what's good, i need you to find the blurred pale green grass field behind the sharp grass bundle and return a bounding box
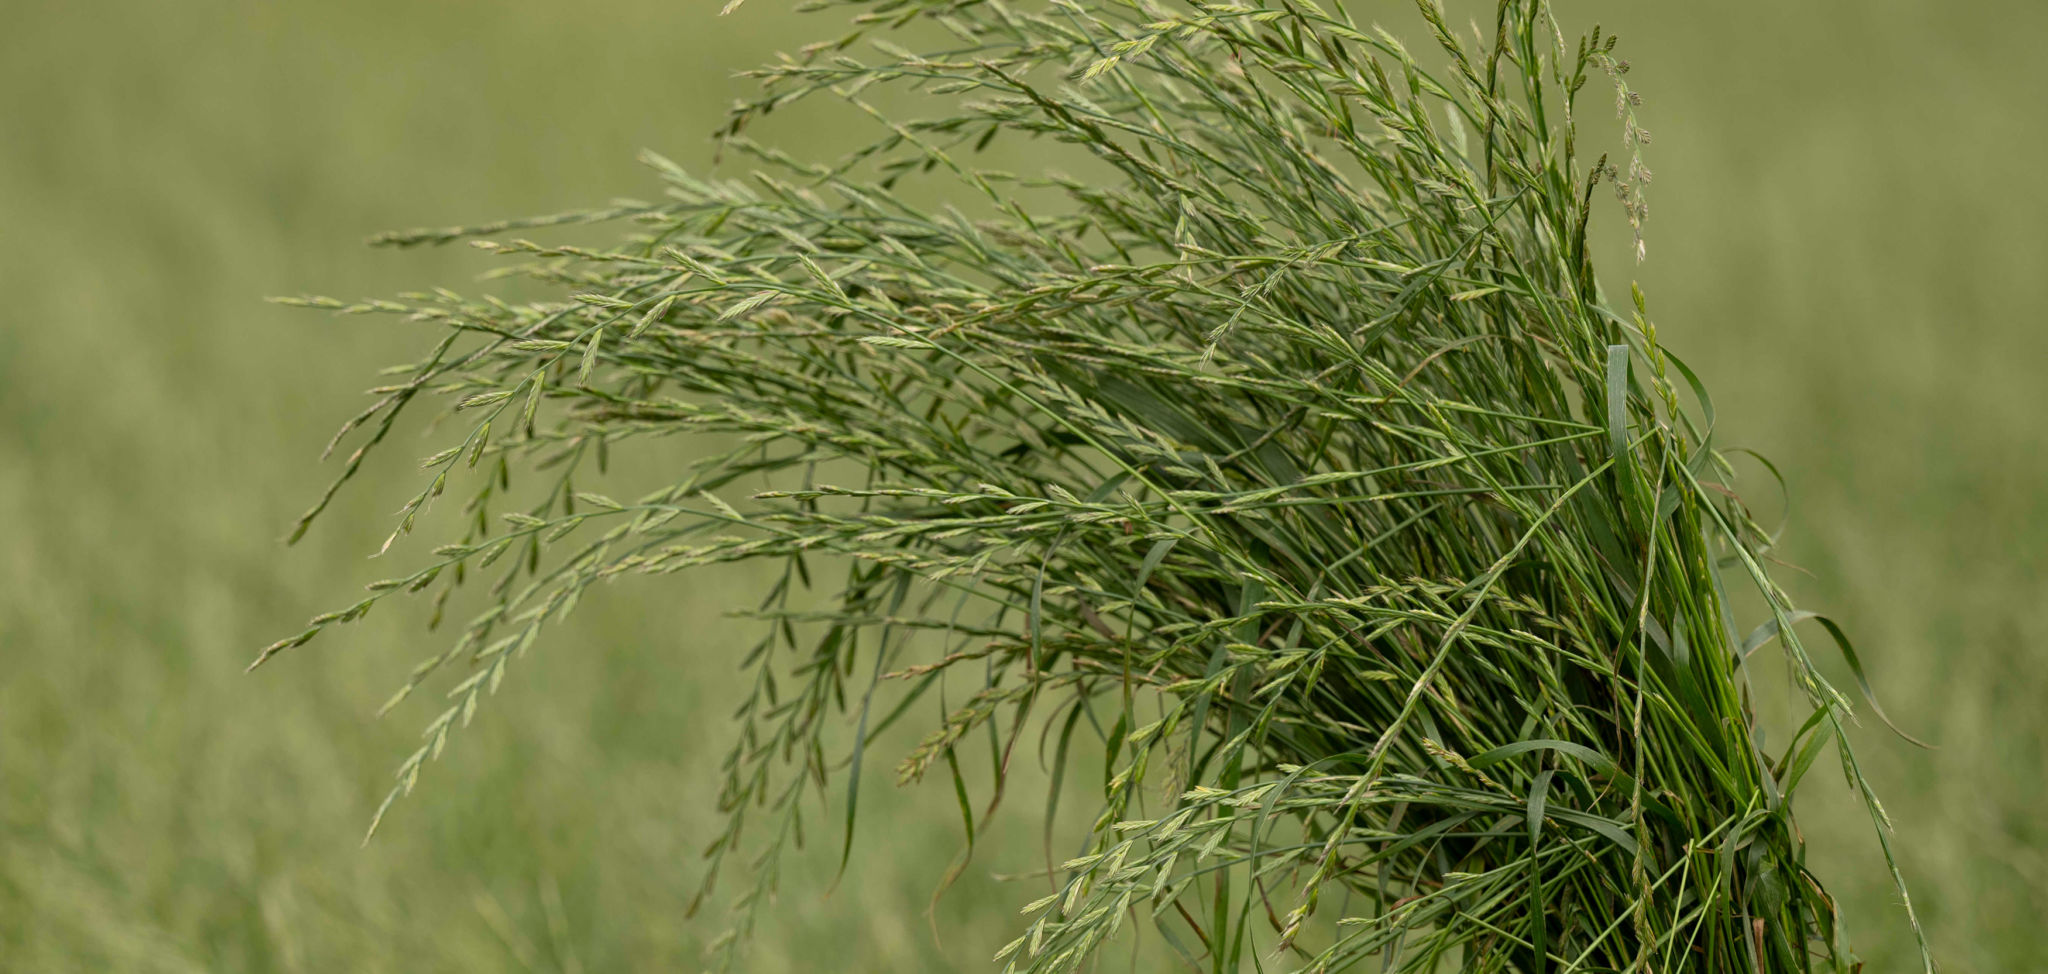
[0,0,2048,972]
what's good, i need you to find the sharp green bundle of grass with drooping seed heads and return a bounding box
[262,0,1931,972]
